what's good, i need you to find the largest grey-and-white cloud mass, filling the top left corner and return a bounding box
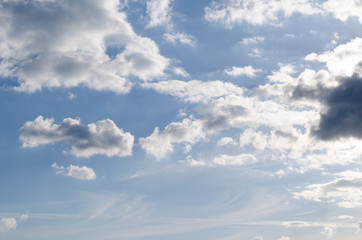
[0,0,169,93]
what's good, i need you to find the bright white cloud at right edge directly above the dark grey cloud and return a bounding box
[305,38,362,77]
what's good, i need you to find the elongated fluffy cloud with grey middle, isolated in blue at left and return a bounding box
[20,116,134,157]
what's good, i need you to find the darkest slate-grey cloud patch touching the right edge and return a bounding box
[313,76,362,140]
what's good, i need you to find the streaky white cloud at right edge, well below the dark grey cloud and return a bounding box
[294,171,362,208]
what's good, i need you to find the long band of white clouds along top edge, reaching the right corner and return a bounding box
[205,0,362,28]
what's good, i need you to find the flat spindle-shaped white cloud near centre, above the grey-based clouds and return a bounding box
[141,80,243,103]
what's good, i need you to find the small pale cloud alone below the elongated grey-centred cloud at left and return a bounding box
[52,163,97,180]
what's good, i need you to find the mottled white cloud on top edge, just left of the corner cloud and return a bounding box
[205,0,320,28]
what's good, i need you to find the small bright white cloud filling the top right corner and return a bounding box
[323,0,362,23]
